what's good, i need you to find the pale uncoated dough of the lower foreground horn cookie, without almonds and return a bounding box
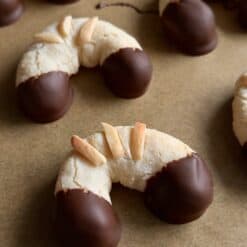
[55,126,194,202]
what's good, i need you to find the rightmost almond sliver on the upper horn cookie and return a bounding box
[78,17,99,46]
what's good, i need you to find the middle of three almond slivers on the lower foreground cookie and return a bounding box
[101,123,124,159]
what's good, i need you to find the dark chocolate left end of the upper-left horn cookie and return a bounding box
[17,71,73,123]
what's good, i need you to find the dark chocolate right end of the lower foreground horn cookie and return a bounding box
[145,154,213,224]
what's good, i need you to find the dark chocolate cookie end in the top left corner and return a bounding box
[0,0,24,27]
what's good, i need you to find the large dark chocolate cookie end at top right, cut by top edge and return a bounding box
[161,0,218,55]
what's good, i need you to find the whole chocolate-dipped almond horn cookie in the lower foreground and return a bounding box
[55,123,213,247]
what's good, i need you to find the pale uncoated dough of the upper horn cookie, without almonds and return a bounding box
[16,18,142,86]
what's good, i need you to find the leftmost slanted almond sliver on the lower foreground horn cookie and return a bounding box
[71,135,106,166]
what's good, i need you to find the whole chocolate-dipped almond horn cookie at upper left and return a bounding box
[16,16,152,122]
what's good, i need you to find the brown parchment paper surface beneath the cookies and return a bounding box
[0,0,247,247]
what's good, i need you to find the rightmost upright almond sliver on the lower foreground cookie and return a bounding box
[131,122,146,160]
